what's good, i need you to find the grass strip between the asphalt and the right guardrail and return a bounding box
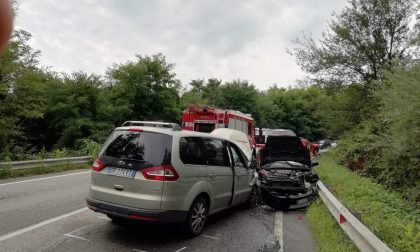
[307,199,359,252]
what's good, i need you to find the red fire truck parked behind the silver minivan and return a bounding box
[182,104,255,148]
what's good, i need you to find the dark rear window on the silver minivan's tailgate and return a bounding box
[99,130,172,168]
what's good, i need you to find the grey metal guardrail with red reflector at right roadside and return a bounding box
[318,181,392,252]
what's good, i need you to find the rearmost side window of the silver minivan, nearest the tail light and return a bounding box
[179,137,206,165]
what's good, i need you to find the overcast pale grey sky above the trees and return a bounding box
[16,0,346,89]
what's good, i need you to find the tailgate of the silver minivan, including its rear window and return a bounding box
[91,130,172,209]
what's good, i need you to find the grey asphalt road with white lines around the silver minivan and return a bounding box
[0,170,318,252]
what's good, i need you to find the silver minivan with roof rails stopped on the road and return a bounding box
[87,126,258,236]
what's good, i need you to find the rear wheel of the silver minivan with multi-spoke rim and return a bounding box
[184,197,209,237]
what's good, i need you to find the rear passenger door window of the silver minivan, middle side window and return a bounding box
[204,138,230,167]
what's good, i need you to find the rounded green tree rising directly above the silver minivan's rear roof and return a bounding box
[107,54,181,123]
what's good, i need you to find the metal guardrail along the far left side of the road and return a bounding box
[0,156,92,170]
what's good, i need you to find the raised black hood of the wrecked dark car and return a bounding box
[261,136,311,167]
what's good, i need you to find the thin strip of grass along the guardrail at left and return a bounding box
[0,163,90,179]
